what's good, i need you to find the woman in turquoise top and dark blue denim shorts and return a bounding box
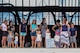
[30,20,37,48]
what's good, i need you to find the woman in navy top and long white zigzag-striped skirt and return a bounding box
[61,18,69,47]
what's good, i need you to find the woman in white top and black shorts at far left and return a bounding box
[1,20,8,48]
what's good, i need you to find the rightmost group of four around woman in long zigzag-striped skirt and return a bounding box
[52,18,77,48]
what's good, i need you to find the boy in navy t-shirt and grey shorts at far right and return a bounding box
[70,23,77,48]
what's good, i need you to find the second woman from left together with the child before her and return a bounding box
[8,21,15,47]
